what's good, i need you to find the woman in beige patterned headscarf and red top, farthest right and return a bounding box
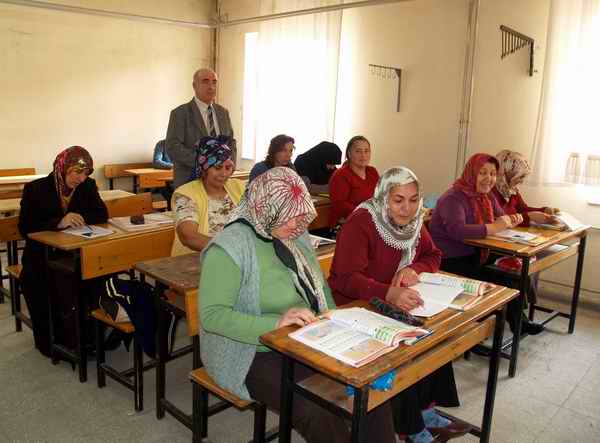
[492,149,560,226]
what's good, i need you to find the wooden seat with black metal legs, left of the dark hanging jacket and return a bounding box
[91,309,147,411]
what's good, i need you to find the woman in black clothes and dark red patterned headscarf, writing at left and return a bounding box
[19,146,108,357]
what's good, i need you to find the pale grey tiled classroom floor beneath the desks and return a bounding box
[0,286,600,443]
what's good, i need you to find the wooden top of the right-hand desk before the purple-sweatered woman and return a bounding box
[465,227,589,257]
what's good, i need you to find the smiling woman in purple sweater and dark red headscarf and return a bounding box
[430,154,544,335]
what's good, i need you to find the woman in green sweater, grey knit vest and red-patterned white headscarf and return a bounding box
[198,167,395,443]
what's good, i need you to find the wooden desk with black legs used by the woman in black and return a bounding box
[29,224,175,382]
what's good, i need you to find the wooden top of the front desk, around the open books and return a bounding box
[260,286,518,388]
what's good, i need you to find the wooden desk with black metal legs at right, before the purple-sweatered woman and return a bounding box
[465,227,589,377]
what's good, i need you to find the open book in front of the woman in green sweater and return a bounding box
[290,308,431,368]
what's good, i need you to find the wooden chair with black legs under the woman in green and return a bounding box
[185,291,278,443]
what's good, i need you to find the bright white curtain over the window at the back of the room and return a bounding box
[244,0,341,161]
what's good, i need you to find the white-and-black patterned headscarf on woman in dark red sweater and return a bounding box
[357,167,425,270]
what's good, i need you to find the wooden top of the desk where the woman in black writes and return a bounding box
[29,223,173,251]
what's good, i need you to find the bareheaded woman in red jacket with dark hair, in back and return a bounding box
[329,135,379,228]
